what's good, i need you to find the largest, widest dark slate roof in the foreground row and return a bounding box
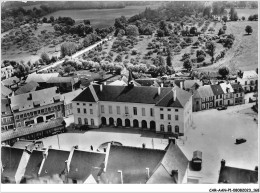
[101,145,165,184]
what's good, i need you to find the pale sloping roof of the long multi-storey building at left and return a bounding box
[11,87,60,111]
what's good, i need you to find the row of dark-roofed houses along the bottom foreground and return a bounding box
[1,138,205,184]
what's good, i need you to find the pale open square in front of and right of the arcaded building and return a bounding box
[42,103,258,183]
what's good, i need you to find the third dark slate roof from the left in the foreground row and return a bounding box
[40,149,70,177]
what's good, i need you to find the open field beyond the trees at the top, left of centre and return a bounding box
[46,5,160,28]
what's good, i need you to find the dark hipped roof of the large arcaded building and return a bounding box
[73,85,191,107]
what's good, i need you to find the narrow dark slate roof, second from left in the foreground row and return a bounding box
[24,150,43,178]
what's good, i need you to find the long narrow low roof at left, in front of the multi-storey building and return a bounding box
[1,118,63,142]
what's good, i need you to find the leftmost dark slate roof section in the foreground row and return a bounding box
[1,146,24,182]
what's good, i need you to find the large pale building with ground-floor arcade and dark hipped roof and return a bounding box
[72,85,192,135]
